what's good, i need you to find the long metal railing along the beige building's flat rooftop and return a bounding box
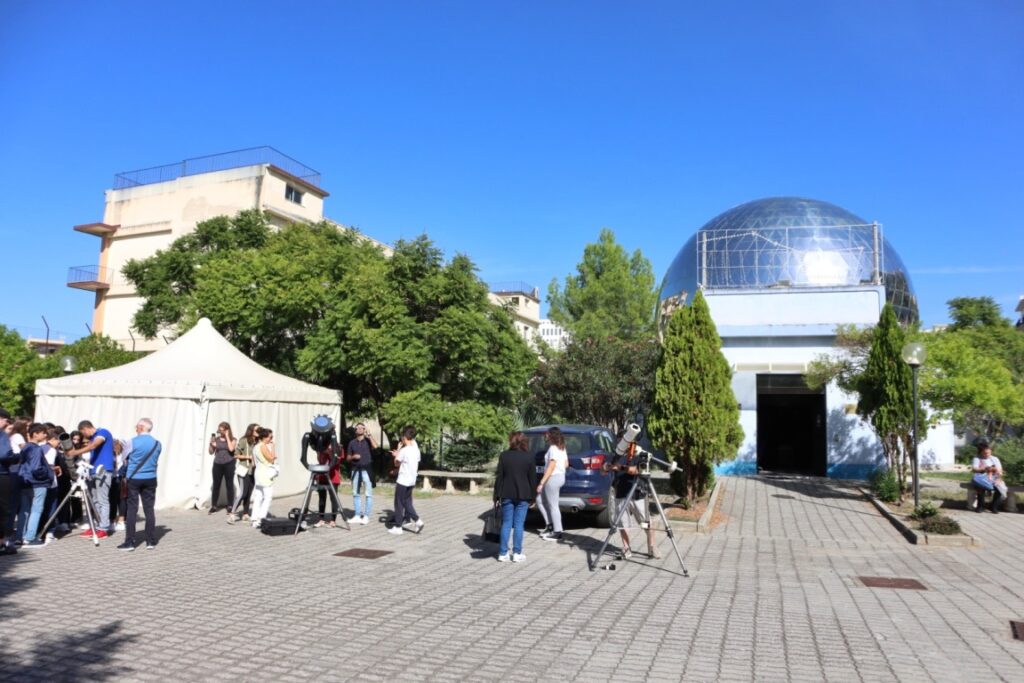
[114,146,321,189]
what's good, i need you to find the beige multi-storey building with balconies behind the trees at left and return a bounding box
[68,147,390,351]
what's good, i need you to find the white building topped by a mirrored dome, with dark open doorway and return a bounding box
[658,197,953,478]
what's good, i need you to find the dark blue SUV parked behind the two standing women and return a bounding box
[522,425,615,528]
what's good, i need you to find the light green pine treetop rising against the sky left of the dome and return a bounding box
[548,228,657,340]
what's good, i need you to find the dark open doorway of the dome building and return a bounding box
[758,375,827,476]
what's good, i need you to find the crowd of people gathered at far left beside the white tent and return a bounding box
[0,409,162,555]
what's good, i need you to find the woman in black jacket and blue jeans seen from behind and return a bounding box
[495,432,537,562]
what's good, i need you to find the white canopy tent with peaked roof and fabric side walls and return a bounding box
[36,317,341,508]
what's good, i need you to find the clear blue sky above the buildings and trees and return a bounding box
[0,0,1024,339]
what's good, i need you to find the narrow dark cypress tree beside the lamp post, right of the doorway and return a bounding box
[857,303,925,495]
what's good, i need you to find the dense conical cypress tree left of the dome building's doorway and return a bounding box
[647,292,743,504]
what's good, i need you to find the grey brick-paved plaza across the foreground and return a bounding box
[0,477,1024,681]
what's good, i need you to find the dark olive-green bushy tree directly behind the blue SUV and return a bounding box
[528,337,660,432]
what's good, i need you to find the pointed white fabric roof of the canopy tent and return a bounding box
[36,317,341,403]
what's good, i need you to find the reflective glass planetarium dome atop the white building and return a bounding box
[658,197,918,323]
